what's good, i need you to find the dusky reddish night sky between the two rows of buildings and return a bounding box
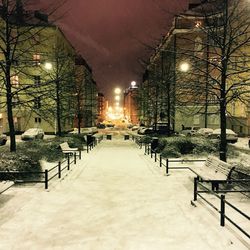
[33,0,188,100]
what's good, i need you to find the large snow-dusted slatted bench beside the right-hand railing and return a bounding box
[190,156,235,191]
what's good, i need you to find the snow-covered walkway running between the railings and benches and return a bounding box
[0,135,250,250]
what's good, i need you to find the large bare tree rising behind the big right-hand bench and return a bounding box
[174,0,250,161]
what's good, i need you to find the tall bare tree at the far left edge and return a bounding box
[0,0,52,151]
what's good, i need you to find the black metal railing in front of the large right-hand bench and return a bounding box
[194,177,250,239]
